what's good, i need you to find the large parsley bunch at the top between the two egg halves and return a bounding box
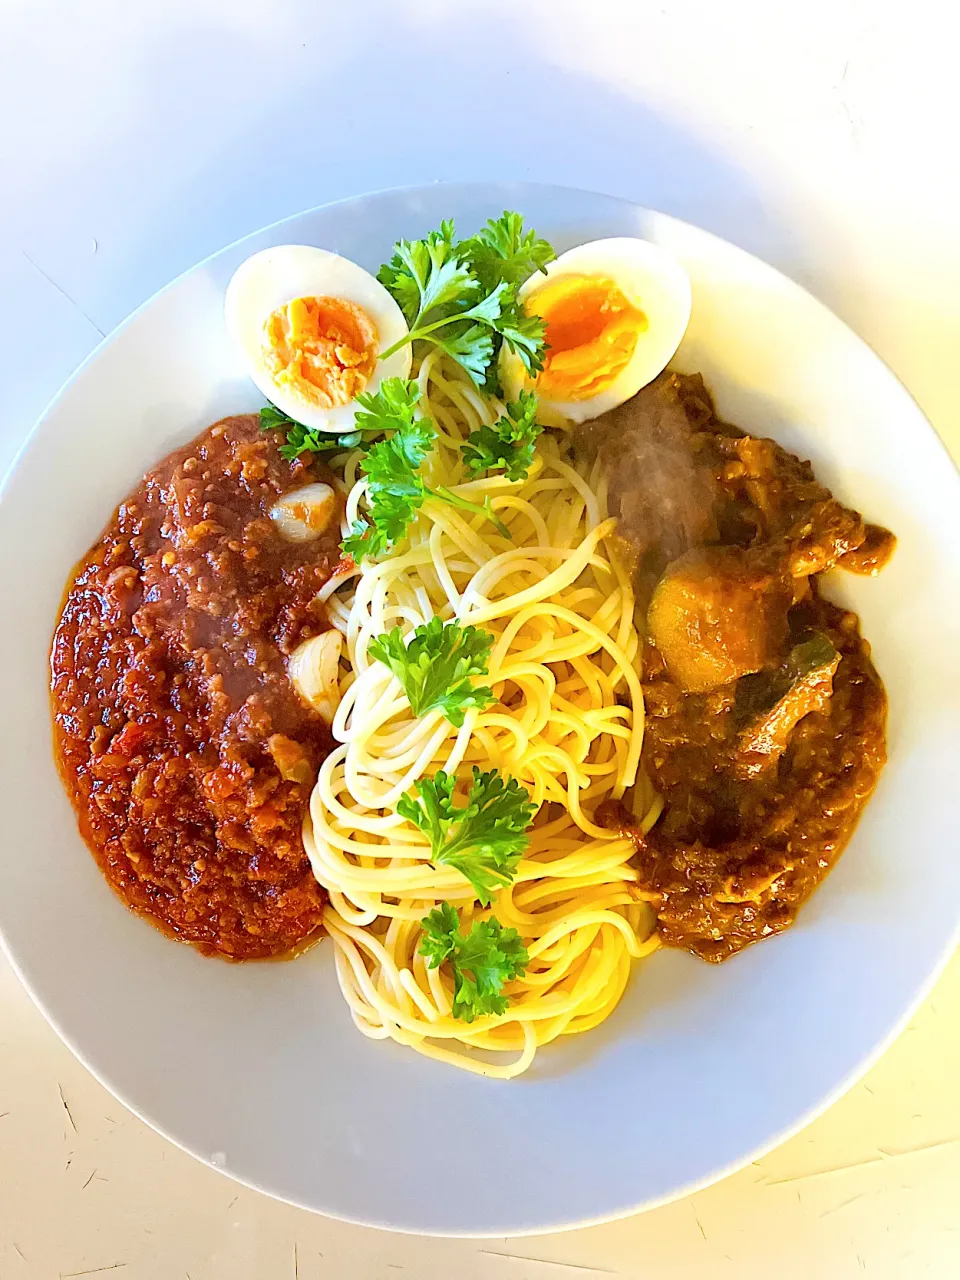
[378,212,556,387]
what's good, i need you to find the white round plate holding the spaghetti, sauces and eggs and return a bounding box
[0,184,960,1235]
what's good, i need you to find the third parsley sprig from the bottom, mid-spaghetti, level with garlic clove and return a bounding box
[367,618,497,728]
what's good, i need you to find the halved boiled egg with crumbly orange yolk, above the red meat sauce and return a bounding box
[224,244,411,431]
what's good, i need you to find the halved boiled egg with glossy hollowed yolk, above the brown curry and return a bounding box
[499,237,690,426]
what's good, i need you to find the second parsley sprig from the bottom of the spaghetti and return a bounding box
[397,765,536,906]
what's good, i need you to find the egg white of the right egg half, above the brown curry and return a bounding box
[499,236,691,425]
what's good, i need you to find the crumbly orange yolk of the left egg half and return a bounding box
[264,297,379,408]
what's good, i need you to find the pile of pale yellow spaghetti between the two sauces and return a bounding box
[303,352,658,1079]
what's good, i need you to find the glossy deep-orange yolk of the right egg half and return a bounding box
[524,275,648,401]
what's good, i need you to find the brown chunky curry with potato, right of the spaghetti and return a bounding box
[577,374,895,961]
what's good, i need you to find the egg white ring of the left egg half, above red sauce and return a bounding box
[224,244,412,431]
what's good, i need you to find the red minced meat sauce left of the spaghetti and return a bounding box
[51,415,339,960]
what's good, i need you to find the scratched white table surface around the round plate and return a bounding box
[0,0,960,1280]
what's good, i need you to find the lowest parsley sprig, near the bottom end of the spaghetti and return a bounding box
[420,902,530,1023]
